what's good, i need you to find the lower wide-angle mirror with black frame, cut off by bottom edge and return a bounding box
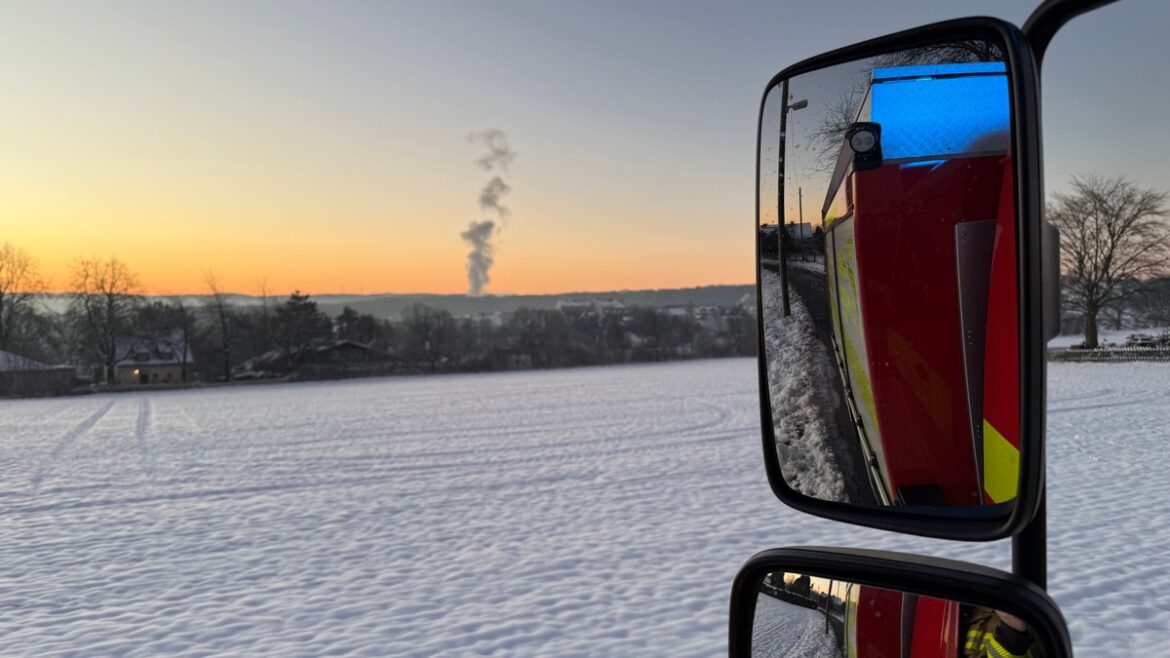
[729,548,1072,658]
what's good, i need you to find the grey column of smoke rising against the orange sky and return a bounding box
[459,129,516,296]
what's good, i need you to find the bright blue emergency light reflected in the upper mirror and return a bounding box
[858,62,1011,162]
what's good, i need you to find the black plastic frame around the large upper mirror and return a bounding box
[752,18,1046,541]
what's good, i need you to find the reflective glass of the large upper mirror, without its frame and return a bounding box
[757,41,1020,512]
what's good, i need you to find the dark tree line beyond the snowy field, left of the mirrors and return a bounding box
[0,248,756,382]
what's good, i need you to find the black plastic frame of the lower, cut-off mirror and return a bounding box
[728,547,1073,658]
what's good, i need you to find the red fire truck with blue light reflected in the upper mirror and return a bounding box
[823,63,1019,506]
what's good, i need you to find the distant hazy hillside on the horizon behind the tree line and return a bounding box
[36,285,756,317]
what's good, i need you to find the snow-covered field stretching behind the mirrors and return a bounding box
[0,359,1170,657]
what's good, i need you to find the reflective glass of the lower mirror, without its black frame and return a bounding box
[751,571,1042,658]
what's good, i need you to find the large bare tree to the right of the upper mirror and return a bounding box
[1047,176,1170,348]
